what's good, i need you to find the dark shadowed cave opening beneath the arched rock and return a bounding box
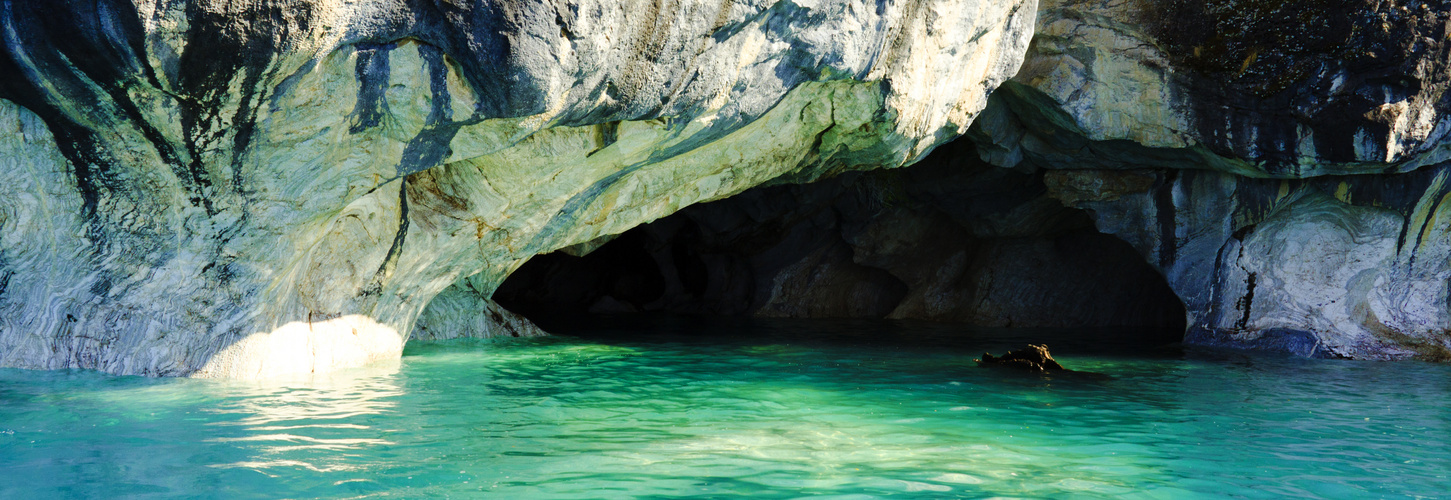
[493,139,1185,345]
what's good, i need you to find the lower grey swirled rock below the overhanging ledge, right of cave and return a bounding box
[1048,167,1451,361]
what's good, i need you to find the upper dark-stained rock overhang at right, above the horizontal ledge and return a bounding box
[982,0,1451,178]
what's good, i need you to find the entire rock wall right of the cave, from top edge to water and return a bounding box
[969,0,1451,359]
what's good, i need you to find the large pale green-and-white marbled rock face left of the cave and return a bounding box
[0,0,1036,377]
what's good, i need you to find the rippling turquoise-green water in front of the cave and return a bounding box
[0,320,1451,499]
